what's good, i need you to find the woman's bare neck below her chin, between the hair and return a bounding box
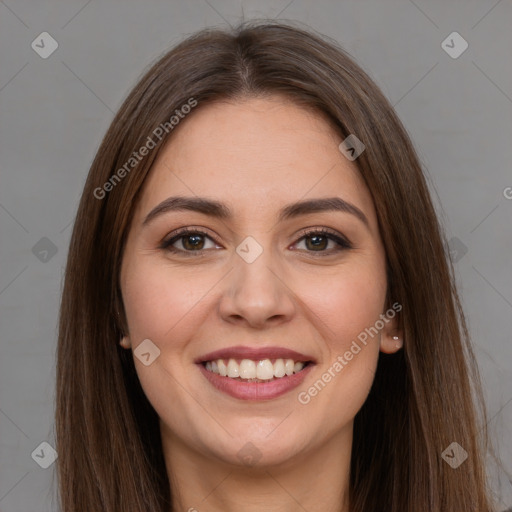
[162,425,352,512]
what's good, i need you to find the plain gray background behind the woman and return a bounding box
[0,0,512,512]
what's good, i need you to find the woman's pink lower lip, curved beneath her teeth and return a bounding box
[197,363,314,400]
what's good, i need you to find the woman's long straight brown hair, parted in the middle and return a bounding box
[56,22,492,512]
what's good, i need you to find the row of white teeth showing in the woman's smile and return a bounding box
[205,359,305,380]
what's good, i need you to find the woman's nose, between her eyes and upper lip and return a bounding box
[219,246,296,329]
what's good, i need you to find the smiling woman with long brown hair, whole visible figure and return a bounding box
[56,24,492,512]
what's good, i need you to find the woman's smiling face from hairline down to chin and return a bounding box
[121,96,396,465]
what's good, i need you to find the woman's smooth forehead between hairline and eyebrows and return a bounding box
[134,96,375,228]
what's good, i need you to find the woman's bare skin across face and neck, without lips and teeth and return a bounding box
[121,96,401,512]
